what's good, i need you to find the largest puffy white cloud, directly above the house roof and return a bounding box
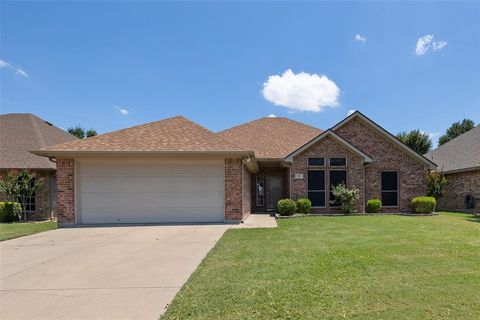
[262,69,340,112]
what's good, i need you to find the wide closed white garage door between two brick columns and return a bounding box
[76,160,224,224]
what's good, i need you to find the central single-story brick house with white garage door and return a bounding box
[30,112,436,224]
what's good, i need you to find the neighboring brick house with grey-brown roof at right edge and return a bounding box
[425,127,480,212]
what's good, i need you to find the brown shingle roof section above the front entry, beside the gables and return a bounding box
[218,117,323,159]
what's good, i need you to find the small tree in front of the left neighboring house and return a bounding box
[0,170,42,221]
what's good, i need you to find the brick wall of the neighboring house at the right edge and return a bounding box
[437,170,480,212]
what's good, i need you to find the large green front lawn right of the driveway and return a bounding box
[162,213,480,319]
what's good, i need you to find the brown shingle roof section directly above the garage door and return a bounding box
[36,116,247,154]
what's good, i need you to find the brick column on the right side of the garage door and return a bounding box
[225,158,242,221]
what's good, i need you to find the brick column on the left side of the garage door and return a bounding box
[57,158,75,224]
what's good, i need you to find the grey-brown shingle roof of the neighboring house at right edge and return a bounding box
[425,126,480,172]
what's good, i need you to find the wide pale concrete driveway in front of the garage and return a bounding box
[0,225,231,320]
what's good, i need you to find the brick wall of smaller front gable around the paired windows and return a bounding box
[290,137,365,213]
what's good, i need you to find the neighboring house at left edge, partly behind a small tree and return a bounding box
[0,113,77,220]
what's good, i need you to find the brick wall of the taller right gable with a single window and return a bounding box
[336,118,428,212]
